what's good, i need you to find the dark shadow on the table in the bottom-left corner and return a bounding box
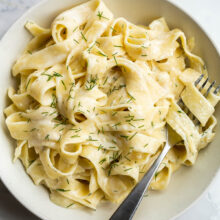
[0,180,39,220]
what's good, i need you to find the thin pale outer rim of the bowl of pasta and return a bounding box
[0,0,220,220]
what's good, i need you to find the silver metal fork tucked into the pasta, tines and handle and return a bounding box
[110,74,220,220]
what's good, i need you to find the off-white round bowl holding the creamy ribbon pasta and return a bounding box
[0,0,220,220]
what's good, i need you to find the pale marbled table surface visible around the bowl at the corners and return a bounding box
[0,0,220,220]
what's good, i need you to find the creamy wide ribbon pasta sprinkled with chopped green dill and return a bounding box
[4,0,220,209]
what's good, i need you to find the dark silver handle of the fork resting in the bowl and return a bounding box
[110,144,170,220]
